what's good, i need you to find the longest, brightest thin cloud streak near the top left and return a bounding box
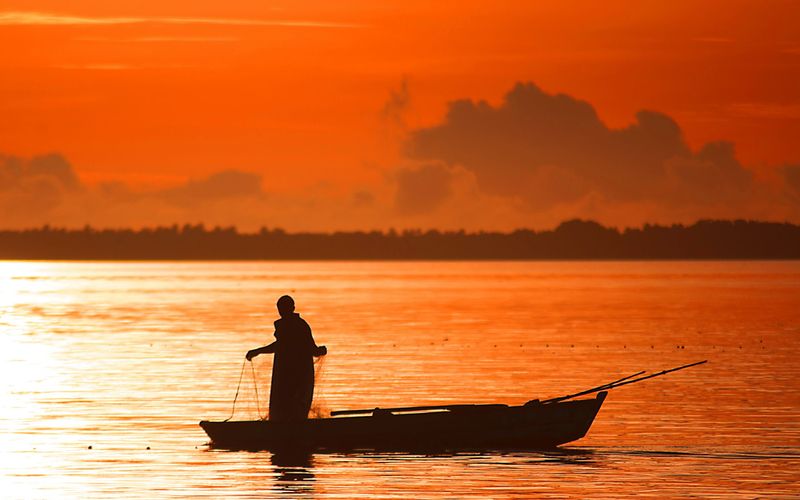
[0,12,361,28]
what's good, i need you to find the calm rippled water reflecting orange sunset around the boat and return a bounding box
[0,262,800,498]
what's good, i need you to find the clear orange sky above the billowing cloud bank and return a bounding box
[0,0,800,227]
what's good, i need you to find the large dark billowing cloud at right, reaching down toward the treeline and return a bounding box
[404,83,798,222]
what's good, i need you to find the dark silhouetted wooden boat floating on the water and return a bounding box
[200,391,607,451]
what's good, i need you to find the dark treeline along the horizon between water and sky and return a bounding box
[0,219,800,260]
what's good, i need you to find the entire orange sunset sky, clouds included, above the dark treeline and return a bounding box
[0,0,800,230]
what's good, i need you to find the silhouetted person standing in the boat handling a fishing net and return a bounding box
[246,295,328,421]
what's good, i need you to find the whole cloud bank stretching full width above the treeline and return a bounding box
[0,83,800,231]
